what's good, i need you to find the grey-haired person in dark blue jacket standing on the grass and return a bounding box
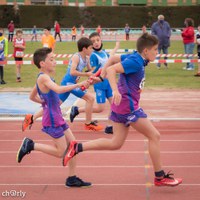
[151,15,171,69]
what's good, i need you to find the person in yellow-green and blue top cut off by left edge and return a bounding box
[0,28,8,84]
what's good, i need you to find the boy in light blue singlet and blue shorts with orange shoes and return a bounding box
[22,37,103,131]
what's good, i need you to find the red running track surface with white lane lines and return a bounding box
[0,92,200,200]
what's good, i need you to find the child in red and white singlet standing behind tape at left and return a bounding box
[13,29,26,82]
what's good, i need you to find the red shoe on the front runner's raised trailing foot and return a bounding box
[63,141,77,166]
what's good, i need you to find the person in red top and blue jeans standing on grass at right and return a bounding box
[181,18,195,70]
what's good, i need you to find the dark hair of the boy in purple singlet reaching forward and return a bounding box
[33,47,52,69]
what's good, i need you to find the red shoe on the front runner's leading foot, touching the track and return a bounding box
[154,172,182,187]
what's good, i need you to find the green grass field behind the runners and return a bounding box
[1,41,200,90]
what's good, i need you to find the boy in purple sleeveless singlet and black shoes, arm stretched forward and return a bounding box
[17,47,91,187]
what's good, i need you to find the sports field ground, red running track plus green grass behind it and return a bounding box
[0,38,200,200]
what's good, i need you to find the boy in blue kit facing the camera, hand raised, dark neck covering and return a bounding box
[70,32,119,134]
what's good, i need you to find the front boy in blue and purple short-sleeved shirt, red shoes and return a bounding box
[63,33,182,186]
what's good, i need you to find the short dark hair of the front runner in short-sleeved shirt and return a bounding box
[136,33,158,53]
